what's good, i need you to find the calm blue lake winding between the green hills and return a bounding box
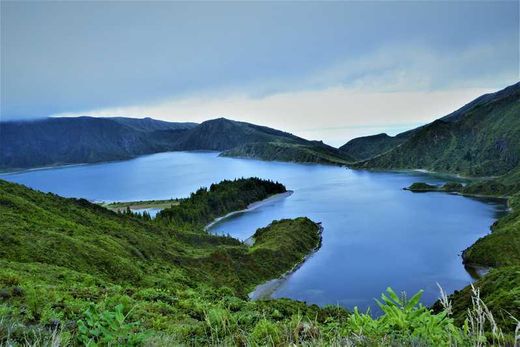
[0,152,504,309]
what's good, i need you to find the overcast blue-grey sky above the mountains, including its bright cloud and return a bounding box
[0,0,520,145]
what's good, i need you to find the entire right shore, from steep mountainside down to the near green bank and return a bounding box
[344,83,520,331]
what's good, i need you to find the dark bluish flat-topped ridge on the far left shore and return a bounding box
[0,117,194,169]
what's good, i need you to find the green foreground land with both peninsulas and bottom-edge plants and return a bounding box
[0,179,516,346]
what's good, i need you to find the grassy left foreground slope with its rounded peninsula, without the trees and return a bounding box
[0,181,334,345]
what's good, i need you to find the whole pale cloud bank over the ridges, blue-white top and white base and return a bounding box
[50,40,518,145]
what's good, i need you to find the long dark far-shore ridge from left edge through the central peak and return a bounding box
[0,117,352,170]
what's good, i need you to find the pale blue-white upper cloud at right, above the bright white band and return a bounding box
[301,39,520,92]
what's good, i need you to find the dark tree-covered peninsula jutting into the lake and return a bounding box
[156,178,287,227]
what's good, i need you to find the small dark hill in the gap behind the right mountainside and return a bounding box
[339,133,409,160]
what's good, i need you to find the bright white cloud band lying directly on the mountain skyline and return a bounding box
[60,87,491,145]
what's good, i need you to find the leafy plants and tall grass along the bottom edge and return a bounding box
[0,286,520,347]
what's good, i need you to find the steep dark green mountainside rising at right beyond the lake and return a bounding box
[348,83,520,176]
